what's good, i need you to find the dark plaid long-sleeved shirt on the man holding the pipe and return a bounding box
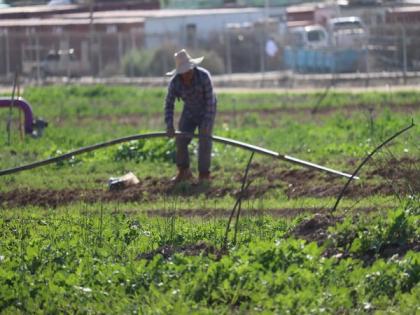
[165,67,217,128]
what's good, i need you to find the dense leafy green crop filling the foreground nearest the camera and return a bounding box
[0,201,420,314]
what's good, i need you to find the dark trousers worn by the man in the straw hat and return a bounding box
[176,114,213,173]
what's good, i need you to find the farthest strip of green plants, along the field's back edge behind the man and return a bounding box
[1,85,420,119]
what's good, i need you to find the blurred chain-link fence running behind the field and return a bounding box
[0,25,420,81]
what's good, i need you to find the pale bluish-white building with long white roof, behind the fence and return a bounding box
[53,8,286,48]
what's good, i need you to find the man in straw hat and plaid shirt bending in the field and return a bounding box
[165,49,217,183]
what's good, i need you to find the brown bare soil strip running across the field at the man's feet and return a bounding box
[0,158,420,208]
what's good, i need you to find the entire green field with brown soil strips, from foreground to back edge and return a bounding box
[0,86,420,314]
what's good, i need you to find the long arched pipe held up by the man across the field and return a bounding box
[0,131,358,179]
